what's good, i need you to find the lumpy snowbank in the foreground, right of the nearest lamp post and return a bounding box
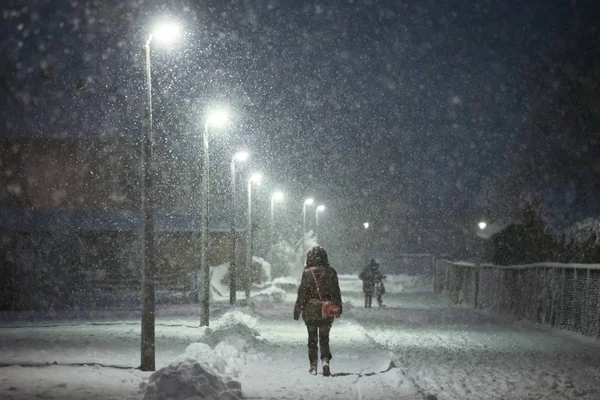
[144,310,265,400]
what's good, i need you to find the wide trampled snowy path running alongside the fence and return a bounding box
[354,293,600,400]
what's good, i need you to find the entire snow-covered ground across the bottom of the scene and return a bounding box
[0,275,600,400]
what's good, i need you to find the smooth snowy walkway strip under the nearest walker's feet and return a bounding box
[242,304,421,399]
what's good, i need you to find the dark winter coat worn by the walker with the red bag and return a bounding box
[294,266,342,322]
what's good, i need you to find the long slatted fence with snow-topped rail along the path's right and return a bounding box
[434,259,600,339]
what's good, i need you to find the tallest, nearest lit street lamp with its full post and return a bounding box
[140,24,179,371]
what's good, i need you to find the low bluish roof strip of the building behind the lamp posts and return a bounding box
[0,208,244,232]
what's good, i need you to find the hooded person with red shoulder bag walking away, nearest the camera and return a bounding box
[294,246,342,376]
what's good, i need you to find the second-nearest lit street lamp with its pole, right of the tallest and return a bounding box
[200,111,227,326]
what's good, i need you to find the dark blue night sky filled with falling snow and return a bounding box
[0,0,596,268]
